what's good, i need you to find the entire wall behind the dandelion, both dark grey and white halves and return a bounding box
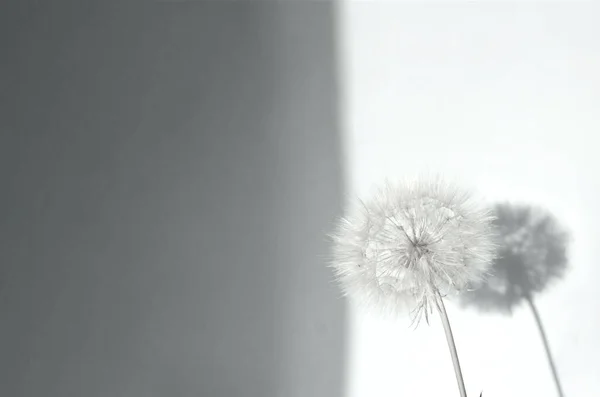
[0,1,600,397]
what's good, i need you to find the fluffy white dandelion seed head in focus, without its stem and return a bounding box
[331,178,496,319]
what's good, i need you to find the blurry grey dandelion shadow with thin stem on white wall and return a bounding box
[461,204,569,397]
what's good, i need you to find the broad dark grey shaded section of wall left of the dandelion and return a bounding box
[0,1,345,397]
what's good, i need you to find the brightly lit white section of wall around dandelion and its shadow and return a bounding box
[339,1,600,397]
